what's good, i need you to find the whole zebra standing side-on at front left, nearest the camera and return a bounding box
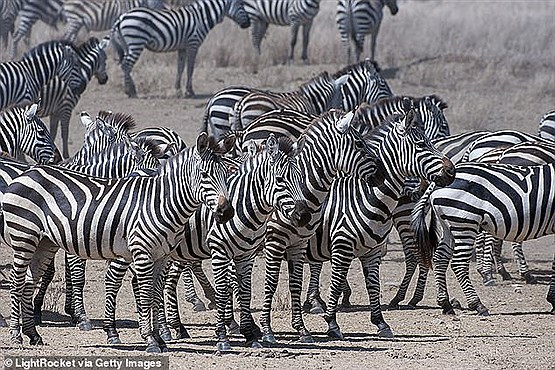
[2,133,234,352]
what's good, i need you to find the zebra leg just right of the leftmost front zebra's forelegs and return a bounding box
[164,261,191,339]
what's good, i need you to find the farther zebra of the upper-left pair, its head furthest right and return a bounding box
[39,37,110,158]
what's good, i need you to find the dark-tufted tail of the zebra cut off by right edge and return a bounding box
[411,182,437,269]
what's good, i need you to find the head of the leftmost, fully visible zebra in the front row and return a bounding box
[192,132,235,223]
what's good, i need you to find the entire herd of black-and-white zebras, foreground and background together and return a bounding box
[0,0,555,358]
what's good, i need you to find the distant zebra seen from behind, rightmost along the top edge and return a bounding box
[335,0,399,63]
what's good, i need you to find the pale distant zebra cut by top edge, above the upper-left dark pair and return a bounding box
[62,0,164,42]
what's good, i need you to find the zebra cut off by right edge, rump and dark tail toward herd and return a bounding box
[413,162,555,315]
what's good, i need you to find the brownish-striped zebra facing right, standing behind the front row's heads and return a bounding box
[229,72,348,130]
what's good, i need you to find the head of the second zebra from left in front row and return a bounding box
[266,134,312,227]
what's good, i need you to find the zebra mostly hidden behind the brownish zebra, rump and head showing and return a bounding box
[202,59,393,137]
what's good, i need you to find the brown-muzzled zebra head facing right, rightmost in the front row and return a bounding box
[365,109,455,194]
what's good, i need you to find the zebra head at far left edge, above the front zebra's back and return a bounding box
[18,104,62,164]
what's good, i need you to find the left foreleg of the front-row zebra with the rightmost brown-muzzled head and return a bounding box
[324,250,354,340]
